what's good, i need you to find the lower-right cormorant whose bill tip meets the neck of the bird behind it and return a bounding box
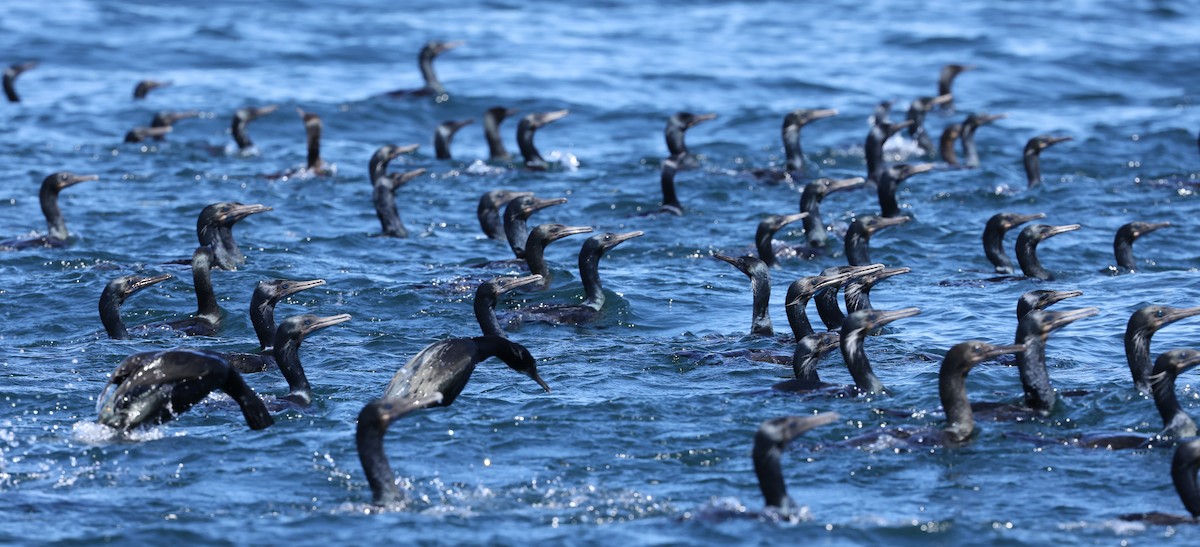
[937,339,1025,445]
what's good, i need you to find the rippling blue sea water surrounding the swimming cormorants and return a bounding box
[0,0,1200,545]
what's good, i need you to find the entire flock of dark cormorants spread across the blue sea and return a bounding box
[7,41,1200,523]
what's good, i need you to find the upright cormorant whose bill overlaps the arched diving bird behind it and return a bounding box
[354,393,451,505]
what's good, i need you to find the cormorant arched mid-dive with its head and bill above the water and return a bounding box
[383,336,550,407]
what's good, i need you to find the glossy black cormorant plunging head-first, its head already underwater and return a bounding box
[97,349,275,432]
